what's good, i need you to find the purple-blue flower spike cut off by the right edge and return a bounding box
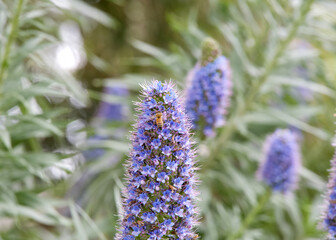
[323,153,336,236]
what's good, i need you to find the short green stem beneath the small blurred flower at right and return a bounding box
[227,189,272,240]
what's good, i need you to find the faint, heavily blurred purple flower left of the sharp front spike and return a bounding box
[97,86,129,121]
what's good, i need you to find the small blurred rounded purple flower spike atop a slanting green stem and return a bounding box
[258,129,301,193]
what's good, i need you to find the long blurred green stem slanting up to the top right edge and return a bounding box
[205,0,314,165]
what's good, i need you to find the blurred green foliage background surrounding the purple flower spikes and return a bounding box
[0,0,336,240]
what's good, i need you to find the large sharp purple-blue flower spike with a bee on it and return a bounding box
[116,81,197,240]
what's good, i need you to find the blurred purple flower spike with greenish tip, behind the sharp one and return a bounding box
[186,38,232,137]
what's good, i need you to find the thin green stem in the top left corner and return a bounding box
[0,0,24,86]
